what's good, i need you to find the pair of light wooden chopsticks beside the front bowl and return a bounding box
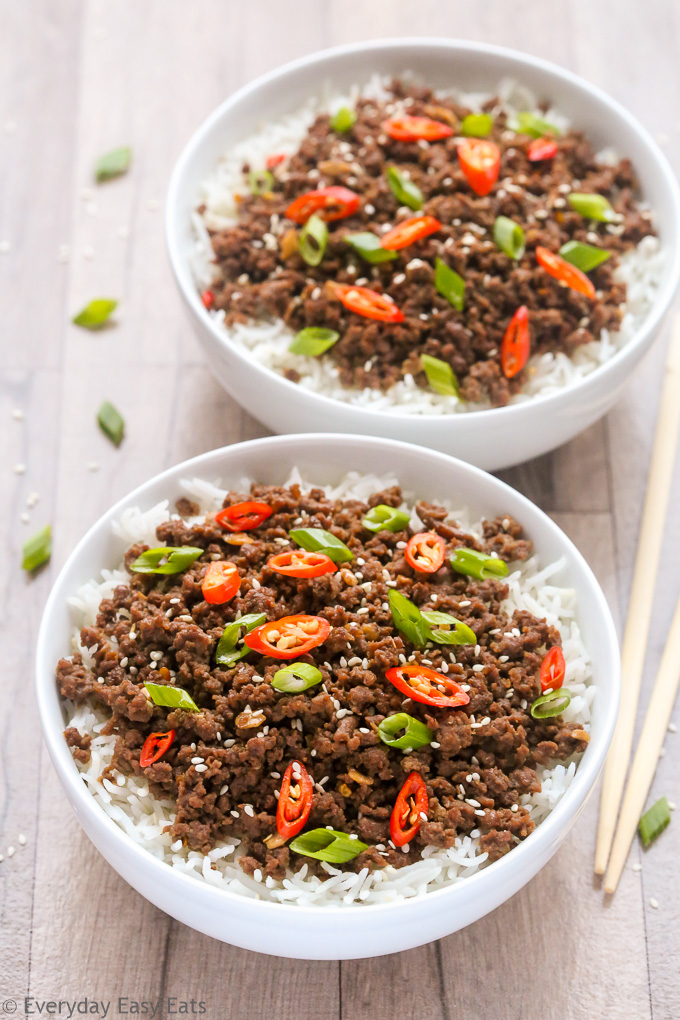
[594,315,680,893]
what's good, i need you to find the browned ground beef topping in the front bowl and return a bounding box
[57,485,588,878]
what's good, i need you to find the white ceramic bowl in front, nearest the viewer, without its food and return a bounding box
[37,434,620,960]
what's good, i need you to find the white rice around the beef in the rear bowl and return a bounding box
[190,77,664,414]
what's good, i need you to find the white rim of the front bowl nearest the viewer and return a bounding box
[36,432,619,921]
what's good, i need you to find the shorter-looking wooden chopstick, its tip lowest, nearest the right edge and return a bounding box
[605,599,680,893]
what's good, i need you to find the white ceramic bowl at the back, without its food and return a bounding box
[166,39,680,470]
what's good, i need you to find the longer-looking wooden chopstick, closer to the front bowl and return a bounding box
[594,315,680,875]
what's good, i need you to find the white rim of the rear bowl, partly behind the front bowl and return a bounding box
[165,37,680,429]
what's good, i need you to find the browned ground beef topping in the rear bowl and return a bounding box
[203,81,653,406]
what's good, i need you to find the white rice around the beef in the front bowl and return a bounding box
[64,472,595,906]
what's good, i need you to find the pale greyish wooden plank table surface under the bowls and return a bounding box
[0,0,680,1020]
